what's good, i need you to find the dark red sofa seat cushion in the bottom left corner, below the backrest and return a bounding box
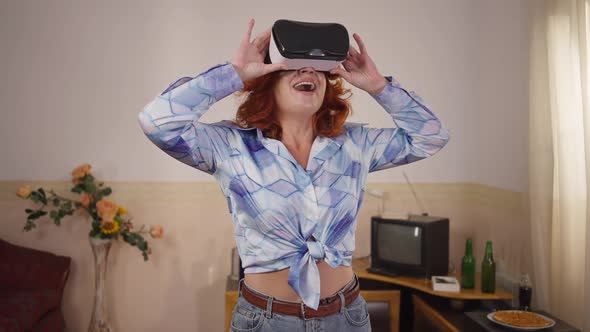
[0,290,61,330]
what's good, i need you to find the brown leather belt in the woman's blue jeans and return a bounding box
[241,277,360,319]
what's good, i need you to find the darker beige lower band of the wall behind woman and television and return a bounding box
[0,181,530,332]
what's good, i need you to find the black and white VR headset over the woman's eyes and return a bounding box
[264,20,349,71]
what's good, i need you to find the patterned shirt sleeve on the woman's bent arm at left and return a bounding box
[138,63,243,174]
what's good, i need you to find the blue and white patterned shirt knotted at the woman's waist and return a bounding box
[139,63,449,309]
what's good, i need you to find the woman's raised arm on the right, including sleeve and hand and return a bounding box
[331,33,449,172]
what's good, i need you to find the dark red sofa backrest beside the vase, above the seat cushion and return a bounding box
[0,239,70,289]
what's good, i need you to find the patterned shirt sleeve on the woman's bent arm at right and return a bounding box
[349,77,449,172]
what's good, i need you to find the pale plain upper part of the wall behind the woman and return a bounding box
[0,0,528,191]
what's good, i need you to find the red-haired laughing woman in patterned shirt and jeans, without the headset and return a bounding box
[139,20,448,332]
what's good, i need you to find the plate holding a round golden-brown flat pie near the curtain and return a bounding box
[487,310,555,331]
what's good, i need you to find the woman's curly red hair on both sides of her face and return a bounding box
[236,71,352,140]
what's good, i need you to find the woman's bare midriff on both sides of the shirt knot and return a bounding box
[244,261,354,302]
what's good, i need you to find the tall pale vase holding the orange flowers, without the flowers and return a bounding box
[88,237,113,332]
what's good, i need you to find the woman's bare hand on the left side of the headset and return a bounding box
[231,19,287,82]
